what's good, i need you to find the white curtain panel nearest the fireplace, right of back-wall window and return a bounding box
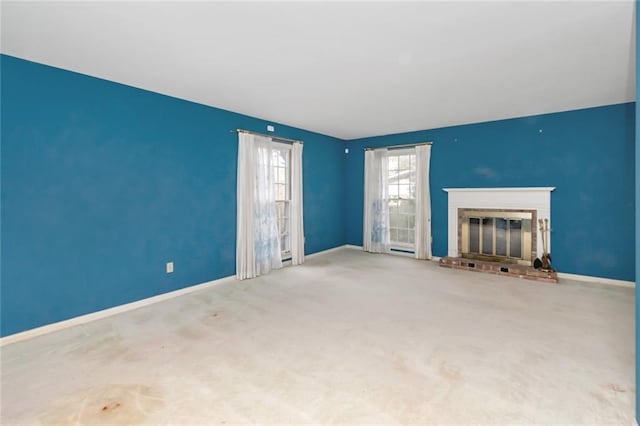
[415,145,431,259]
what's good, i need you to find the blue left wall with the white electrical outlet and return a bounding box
[0,56,345,335]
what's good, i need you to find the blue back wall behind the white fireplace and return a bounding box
[345,103,635,280]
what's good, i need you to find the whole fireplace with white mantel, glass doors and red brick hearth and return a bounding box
[440,187,557,282]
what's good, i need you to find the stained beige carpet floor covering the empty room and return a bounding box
[0,248,636,425]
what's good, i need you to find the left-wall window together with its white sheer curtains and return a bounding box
[236,129,304,280]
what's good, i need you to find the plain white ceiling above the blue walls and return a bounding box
[1,1,635,139]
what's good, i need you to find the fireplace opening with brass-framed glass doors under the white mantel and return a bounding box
[458,209,536,265]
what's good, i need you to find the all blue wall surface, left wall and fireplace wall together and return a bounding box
[0,56,640,335]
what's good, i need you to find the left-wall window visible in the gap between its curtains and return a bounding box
[271,142,291,260]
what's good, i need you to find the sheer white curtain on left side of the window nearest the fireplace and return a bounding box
[363,148,389,253]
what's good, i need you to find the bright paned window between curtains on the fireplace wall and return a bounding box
[387,149,416,251]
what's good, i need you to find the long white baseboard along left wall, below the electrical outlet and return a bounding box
[0,275,236,347]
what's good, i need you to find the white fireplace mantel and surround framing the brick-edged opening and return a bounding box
[443,187,556,257]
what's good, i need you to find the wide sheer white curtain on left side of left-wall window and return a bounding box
[236,132,282,280]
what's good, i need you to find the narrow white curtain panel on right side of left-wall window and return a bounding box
[289,142,304,265]
